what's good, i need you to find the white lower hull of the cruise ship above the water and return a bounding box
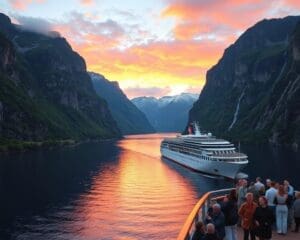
[161,148,247,179]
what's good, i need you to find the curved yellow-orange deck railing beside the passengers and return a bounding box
[177,188,234,240]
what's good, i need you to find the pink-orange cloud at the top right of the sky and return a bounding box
[161,0,270,39]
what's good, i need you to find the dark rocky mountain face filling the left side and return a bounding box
[0,14,121,141]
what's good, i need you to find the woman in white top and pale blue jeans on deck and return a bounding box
[275,185,288,235]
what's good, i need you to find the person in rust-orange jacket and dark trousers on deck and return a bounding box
[238,193,257,240]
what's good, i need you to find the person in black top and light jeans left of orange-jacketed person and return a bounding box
[222,189,239,240]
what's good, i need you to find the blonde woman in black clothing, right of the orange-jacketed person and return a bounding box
[253,197,275,240]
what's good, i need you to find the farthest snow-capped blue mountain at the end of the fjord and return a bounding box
[131,93,198,132]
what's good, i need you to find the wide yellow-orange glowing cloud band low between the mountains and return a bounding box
[73,38,224,91]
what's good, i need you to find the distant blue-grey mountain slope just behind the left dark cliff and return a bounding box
[89,72,155,134]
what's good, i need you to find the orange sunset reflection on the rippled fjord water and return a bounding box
[69,135,197,239]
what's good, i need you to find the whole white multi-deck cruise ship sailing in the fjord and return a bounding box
[160,123,248,179]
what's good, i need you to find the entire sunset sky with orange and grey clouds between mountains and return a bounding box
[0,0,300,98]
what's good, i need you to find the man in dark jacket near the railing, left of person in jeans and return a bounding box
[206,203,225,240]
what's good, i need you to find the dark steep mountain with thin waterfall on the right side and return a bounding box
[189,16,300,146]
